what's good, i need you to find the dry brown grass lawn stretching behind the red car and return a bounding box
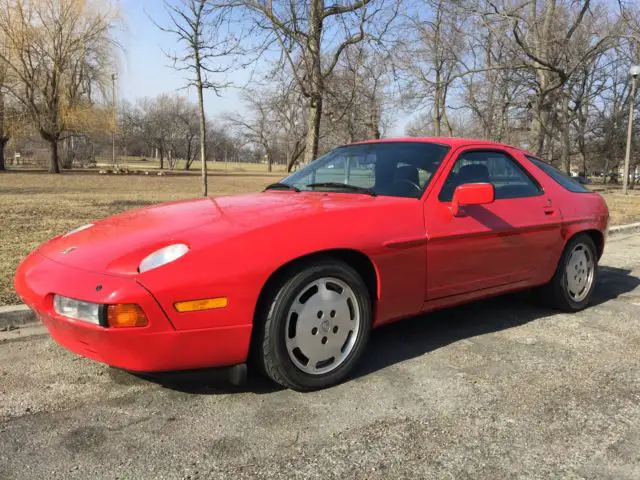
[0,167,640,305]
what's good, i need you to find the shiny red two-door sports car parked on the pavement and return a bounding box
[15,138,609,390]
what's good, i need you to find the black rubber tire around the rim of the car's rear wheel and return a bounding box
[541,233,598,312]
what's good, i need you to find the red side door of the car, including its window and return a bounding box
[425,147,561,302]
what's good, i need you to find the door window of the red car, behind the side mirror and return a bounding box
[438,150,542,202]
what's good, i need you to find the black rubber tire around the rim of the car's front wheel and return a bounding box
[254,259,372,392]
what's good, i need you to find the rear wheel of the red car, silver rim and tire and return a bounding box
[544,233,598,312]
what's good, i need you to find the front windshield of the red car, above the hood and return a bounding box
[280,142,449,198]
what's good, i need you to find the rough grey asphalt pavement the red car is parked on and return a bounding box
[0,235,640,480]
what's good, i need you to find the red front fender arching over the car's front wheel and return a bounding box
[138,199,426,330]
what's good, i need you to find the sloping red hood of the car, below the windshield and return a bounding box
[38,192,384,276]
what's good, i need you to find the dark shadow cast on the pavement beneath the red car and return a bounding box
[121,266,640,395]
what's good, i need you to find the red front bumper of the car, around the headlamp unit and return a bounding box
[14,251,251,372]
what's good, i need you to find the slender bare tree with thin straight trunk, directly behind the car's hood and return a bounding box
[156,0,239,196]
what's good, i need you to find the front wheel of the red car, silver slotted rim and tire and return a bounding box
[258,260,372,391]
